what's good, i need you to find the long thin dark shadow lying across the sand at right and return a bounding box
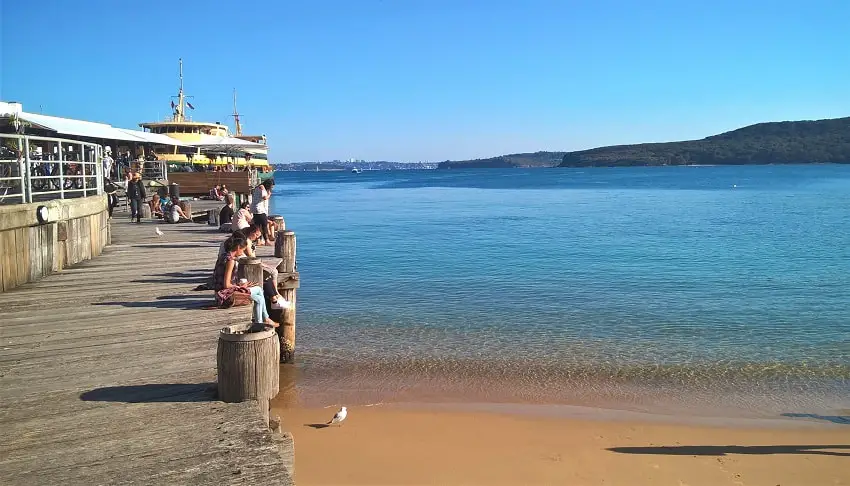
[606,444,850,457]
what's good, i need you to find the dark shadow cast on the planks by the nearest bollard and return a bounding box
[80,383,217,403]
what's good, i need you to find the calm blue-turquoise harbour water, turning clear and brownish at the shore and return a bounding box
[273,166,850,414]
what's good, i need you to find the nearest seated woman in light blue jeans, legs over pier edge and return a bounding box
[213,235,279,328]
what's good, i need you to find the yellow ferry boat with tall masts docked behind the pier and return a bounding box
[139,59,272,179]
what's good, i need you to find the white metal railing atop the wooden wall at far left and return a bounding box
[0,133,103,204]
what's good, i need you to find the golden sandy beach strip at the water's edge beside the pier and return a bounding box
[273,405,850,486]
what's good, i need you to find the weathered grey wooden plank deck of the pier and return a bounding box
[0,217,292,485]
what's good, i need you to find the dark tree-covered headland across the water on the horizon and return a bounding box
[438,117,850,169]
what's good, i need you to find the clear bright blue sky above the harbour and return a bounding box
[0,0,850,162]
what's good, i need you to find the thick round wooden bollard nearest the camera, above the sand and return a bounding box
[216,325,280,403]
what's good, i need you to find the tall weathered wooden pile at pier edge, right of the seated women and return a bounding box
[275,230,300,363]
